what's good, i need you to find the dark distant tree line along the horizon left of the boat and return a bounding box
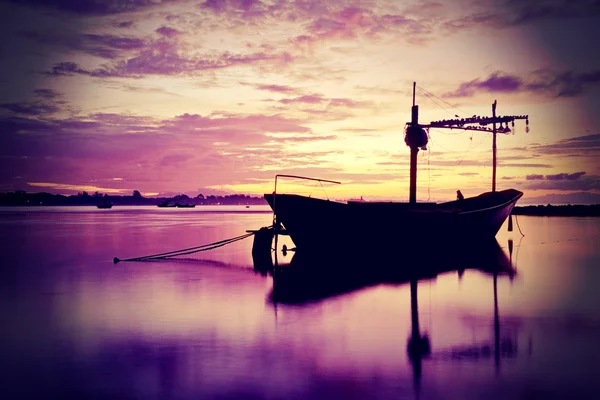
[0,190,267,206]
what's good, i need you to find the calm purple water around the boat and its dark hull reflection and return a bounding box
[0,207,600,399]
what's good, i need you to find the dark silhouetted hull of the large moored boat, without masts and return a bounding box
[265,189,523,250]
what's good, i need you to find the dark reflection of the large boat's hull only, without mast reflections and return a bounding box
[264,239,516,304]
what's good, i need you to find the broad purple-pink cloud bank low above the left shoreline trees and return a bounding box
[0,108,337,191]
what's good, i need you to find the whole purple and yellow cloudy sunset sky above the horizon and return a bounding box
[0,0,600,202]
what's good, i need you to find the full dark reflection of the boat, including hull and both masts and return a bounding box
[255,239,517,389]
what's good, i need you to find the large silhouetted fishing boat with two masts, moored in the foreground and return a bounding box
[264,84,529,254]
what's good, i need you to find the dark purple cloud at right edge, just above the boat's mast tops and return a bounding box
[443,70,600,97]
